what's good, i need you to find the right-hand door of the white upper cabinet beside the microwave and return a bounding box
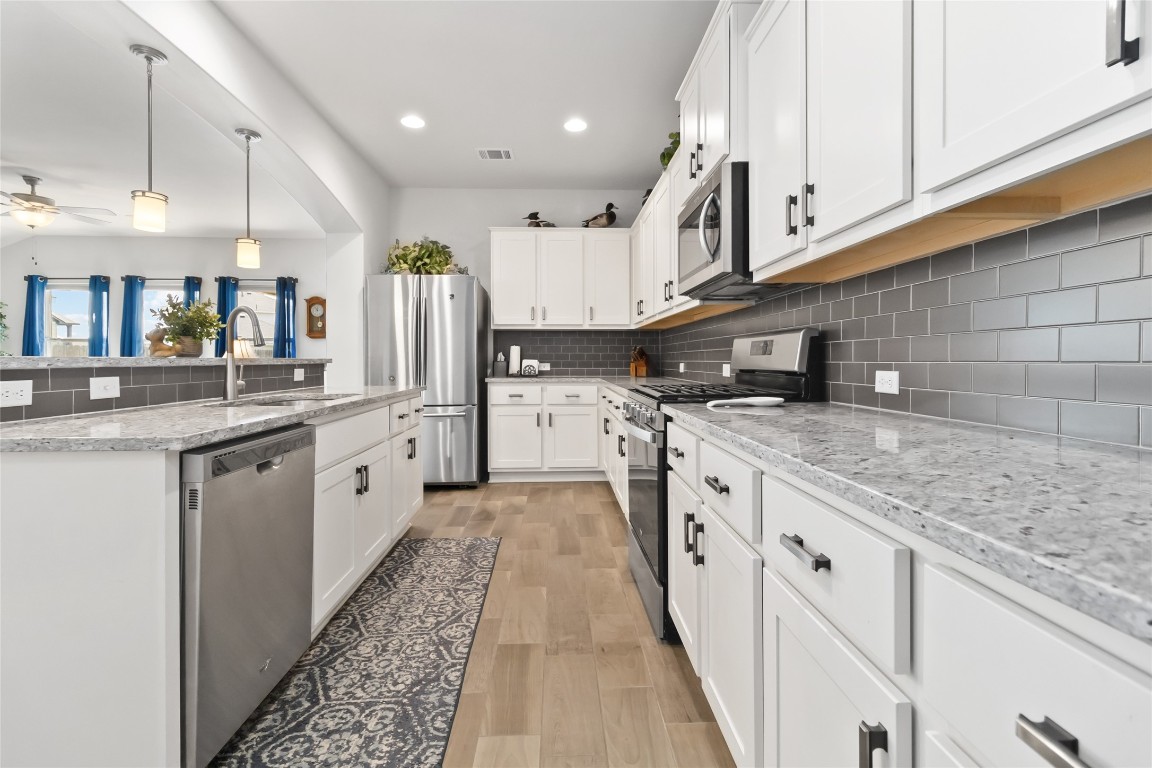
[806,0,912,241]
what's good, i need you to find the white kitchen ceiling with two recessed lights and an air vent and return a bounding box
[218,0,717,189]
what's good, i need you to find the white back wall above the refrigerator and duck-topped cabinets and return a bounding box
[389,188,659,289]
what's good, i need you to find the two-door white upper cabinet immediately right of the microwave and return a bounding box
[748,0,912,269]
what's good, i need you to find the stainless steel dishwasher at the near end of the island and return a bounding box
[181,426,316,768]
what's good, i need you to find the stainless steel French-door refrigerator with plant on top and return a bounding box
[365,275,488,485]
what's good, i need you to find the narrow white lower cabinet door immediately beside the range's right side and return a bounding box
[668,474,704,675]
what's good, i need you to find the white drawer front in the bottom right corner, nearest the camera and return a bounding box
[922,565,1152,767]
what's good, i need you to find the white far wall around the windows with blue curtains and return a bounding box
[0,236,328,357]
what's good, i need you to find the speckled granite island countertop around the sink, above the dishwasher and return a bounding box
[0,387,422,451]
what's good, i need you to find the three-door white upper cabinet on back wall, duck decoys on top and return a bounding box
[491,228,631,328]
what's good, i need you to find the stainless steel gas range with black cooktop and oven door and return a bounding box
[623,328,825,640]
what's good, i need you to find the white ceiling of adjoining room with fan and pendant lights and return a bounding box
[0,0,324,244]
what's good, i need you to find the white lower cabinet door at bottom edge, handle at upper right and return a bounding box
[763,569,912,768]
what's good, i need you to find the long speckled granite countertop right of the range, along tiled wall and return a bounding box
[665,403,1152,642]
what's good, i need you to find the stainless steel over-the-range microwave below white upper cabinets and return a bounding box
[676,162,803,303]
